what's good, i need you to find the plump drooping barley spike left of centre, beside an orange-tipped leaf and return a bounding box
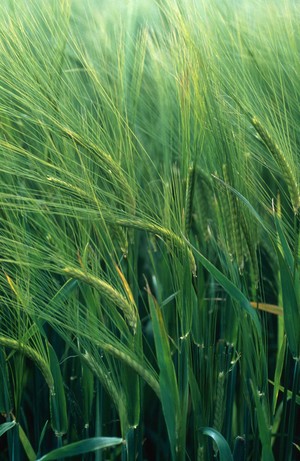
[62,266,137,332]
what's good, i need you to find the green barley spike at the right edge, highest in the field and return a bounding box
[251,116,300,214]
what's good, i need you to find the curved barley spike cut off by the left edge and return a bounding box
[0,335,54,392]
